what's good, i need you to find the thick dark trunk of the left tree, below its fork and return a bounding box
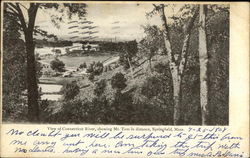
[25,29,39,122]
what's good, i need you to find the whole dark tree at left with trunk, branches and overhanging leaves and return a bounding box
[4,3,86,122]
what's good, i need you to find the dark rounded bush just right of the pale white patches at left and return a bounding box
[61,81,80,101]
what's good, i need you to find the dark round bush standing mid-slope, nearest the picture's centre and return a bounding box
[111,72,127,91]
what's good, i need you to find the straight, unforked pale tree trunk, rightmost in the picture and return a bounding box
[199,5,208,125]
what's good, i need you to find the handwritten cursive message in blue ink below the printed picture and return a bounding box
[5,127,245,157]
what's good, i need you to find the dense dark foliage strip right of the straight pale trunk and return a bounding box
[205,5,230,125]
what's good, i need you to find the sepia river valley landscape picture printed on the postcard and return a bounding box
[1,1,230,126]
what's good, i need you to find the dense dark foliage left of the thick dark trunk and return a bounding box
[2,7,26,120]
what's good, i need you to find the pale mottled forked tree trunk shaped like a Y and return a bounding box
[154,4,198,125]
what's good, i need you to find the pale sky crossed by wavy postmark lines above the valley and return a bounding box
[36,2,164,40]
